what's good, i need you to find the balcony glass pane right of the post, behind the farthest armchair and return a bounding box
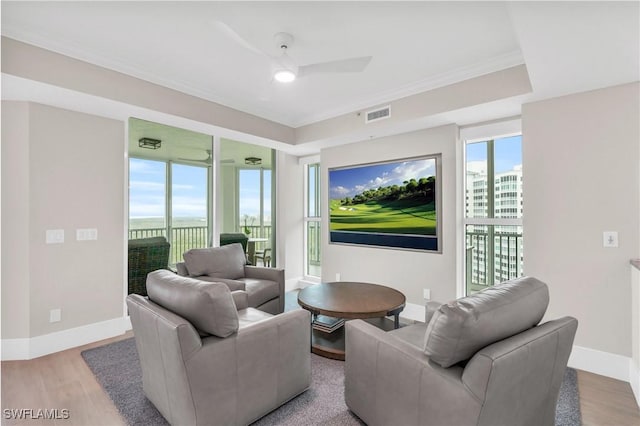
[169,164,208,265]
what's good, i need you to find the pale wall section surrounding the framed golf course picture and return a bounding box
[320,125,458,305]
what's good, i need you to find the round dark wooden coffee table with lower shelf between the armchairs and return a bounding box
[298,281,406,360]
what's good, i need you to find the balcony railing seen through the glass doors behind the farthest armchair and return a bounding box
[129,226,271,265]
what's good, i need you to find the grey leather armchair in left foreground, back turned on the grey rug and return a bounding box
[127,270,311,425]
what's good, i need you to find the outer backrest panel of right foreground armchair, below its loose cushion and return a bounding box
[462,317,578,426]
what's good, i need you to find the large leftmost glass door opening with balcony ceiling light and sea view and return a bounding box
[129,118,213,265]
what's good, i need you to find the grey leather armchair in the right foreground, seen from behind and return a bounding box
[345,277,578,426]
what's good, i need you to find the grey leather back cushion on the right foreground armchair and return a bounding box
[424,277,549,368]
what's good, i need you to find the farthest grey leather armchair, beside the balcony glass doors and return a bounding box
[176,243,284,315]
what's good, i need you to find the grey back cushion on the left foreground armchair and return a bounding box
[147,270,239,337]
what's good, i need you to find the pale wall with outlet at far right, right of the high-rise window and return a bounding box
[522,83,640,357]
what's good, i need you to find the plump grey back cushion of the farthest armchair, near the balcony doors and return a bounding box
[183,243,247,280]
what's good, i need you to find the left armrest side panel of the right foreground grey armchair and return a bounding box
[344,320,472,425]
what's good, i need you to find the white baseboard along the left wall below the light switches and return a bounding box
[1,317,131,361]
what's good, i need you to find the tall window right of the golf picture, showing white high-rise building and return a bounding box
[465,135,524,294]
